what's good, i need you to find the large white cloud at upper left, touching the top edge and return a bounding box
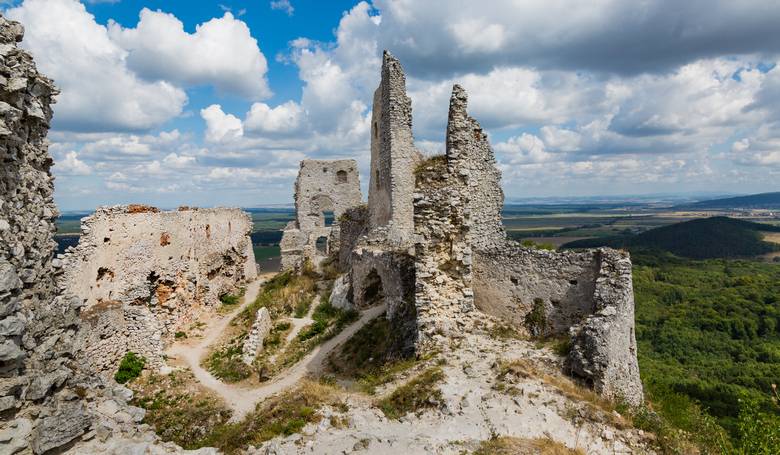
[6,0,187,131]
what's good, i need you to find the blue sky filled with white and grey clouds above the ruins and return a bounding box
[3,0,780,210]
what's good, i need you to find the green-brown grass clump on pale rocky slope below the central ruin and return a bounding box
[377,367,444,419]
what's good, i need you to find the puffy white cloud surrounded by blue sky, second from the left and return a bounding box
[108,8,271,99]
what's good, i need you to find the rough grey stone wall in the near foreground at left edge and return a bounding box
[0,17,98,454]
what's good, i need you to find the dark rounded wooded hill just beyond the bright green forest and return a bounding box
[561,216,780,259]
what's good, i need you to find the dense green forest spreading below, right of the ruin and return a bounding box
[633,253,780,435]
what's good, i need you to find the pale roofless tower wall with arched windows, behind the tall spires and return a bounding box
[280,160,363,270]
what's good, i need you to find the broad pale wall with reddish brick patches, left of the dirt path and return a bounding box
[62,205,257,373]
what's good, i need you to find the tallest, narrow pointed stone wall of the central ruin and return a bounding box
[368,51,422,243]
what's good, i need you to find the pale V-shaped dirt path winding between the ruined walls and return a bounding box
[167,280,385,421]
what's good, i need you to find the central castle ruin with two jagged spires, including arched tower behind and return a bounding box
[282,52,643,405]
